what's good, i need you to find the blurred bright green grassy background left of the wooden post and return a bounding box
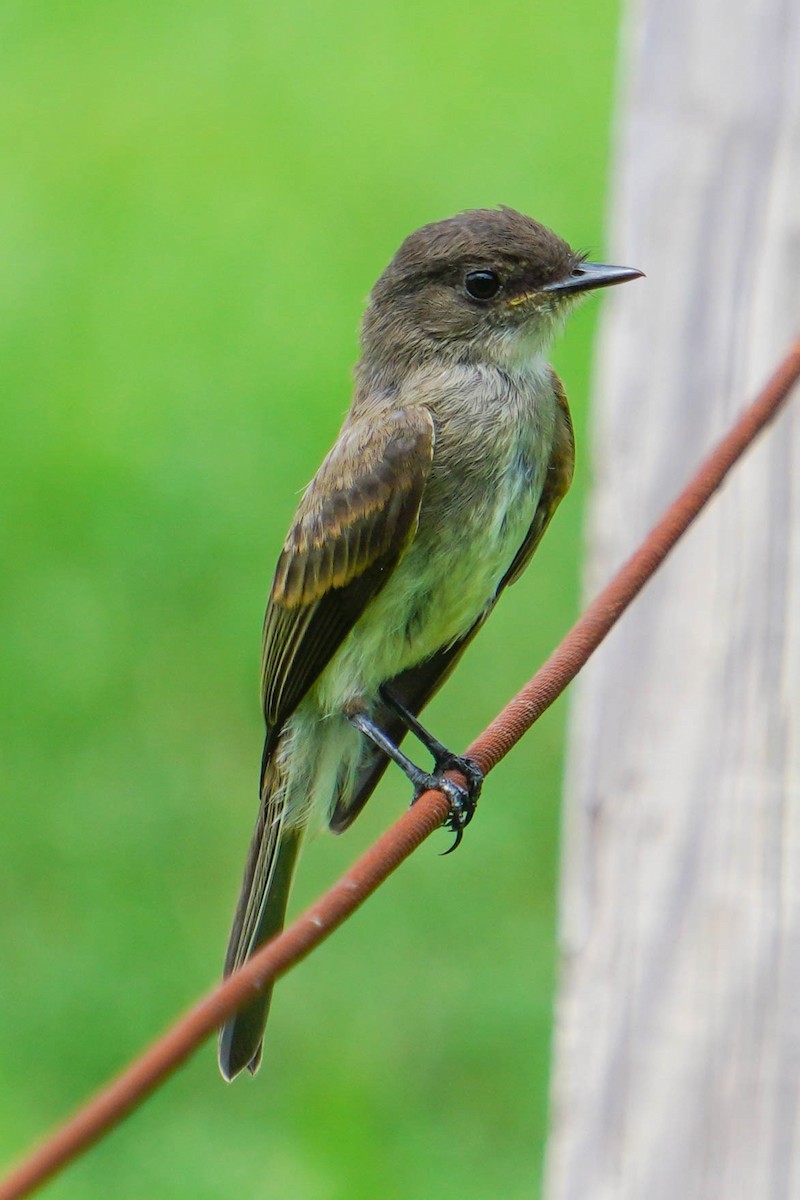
[0,0,618,1200]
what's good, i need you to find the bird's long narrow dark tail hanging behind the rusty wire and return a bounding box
[218,754,302,1080]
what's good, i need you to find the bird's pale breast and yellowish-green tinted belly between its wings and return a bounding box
[315,360,555,712]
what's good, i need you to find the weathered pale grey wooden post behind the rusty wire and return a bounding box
[546,0,800,1200]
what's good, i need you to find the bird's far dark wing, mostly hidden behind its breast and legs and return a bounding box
[330,372,575,833]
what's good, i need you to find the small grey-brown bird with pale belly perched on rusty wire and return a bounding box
[219,208,642,1079]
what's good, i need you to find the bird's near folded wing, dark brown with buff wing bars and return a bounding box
[261,408,434,750]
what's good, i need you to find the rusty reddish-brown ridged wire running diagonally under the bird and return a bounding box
[0,341,800,1200]
